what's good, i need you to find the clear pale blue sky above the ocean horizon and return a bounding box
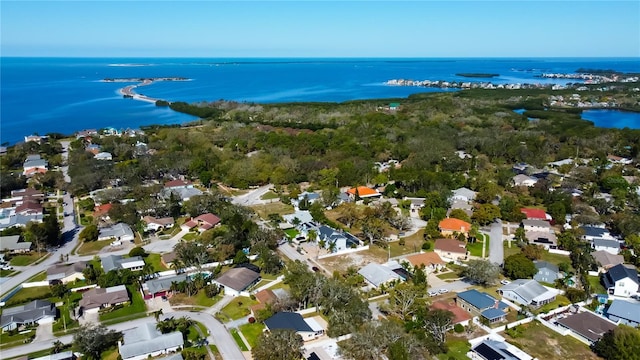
[0,0,640,57]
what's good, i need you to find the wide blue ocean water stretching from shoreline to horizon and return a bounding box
[0,58,640,143]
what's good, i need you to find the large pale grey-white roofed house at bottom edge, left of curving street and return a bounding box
[118,323,184,360]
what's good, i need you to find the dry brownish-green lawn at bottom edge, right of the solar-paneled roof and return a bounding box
[501,321,600,360]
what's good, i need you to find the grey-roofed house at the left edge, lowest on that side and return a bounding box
[0,300,57,331]
